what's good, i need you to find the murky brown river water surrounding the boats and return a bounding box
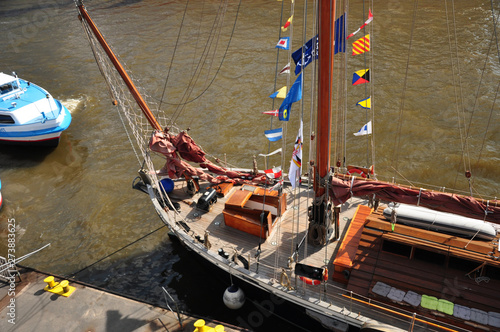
[0,0,500,330]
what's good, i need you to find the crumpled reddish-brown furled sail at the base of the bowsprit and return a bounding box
[149,131,267,184]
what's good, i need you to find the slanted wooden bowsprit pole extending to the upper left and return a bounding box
[76,0,162,130]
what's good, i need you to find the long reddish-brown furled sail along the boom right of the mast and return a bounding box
[329,177,500,224]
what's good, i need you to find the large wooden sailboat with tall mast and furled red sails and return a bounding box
[75,0,500,331]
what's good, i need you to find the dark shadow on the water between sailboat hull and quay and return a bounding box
[70,236,336,331]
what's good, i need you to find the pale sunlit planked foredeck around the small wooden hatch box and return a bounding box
[169,182,365,294]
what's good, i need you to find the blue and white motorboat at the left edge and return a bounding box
[0,73,71,146]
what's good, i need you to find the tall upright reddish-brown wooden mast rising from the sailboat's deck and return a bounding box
[309,0,335,244]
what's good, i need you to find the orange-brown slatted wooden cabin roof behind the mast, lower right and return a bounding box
[348,208,500,331]
